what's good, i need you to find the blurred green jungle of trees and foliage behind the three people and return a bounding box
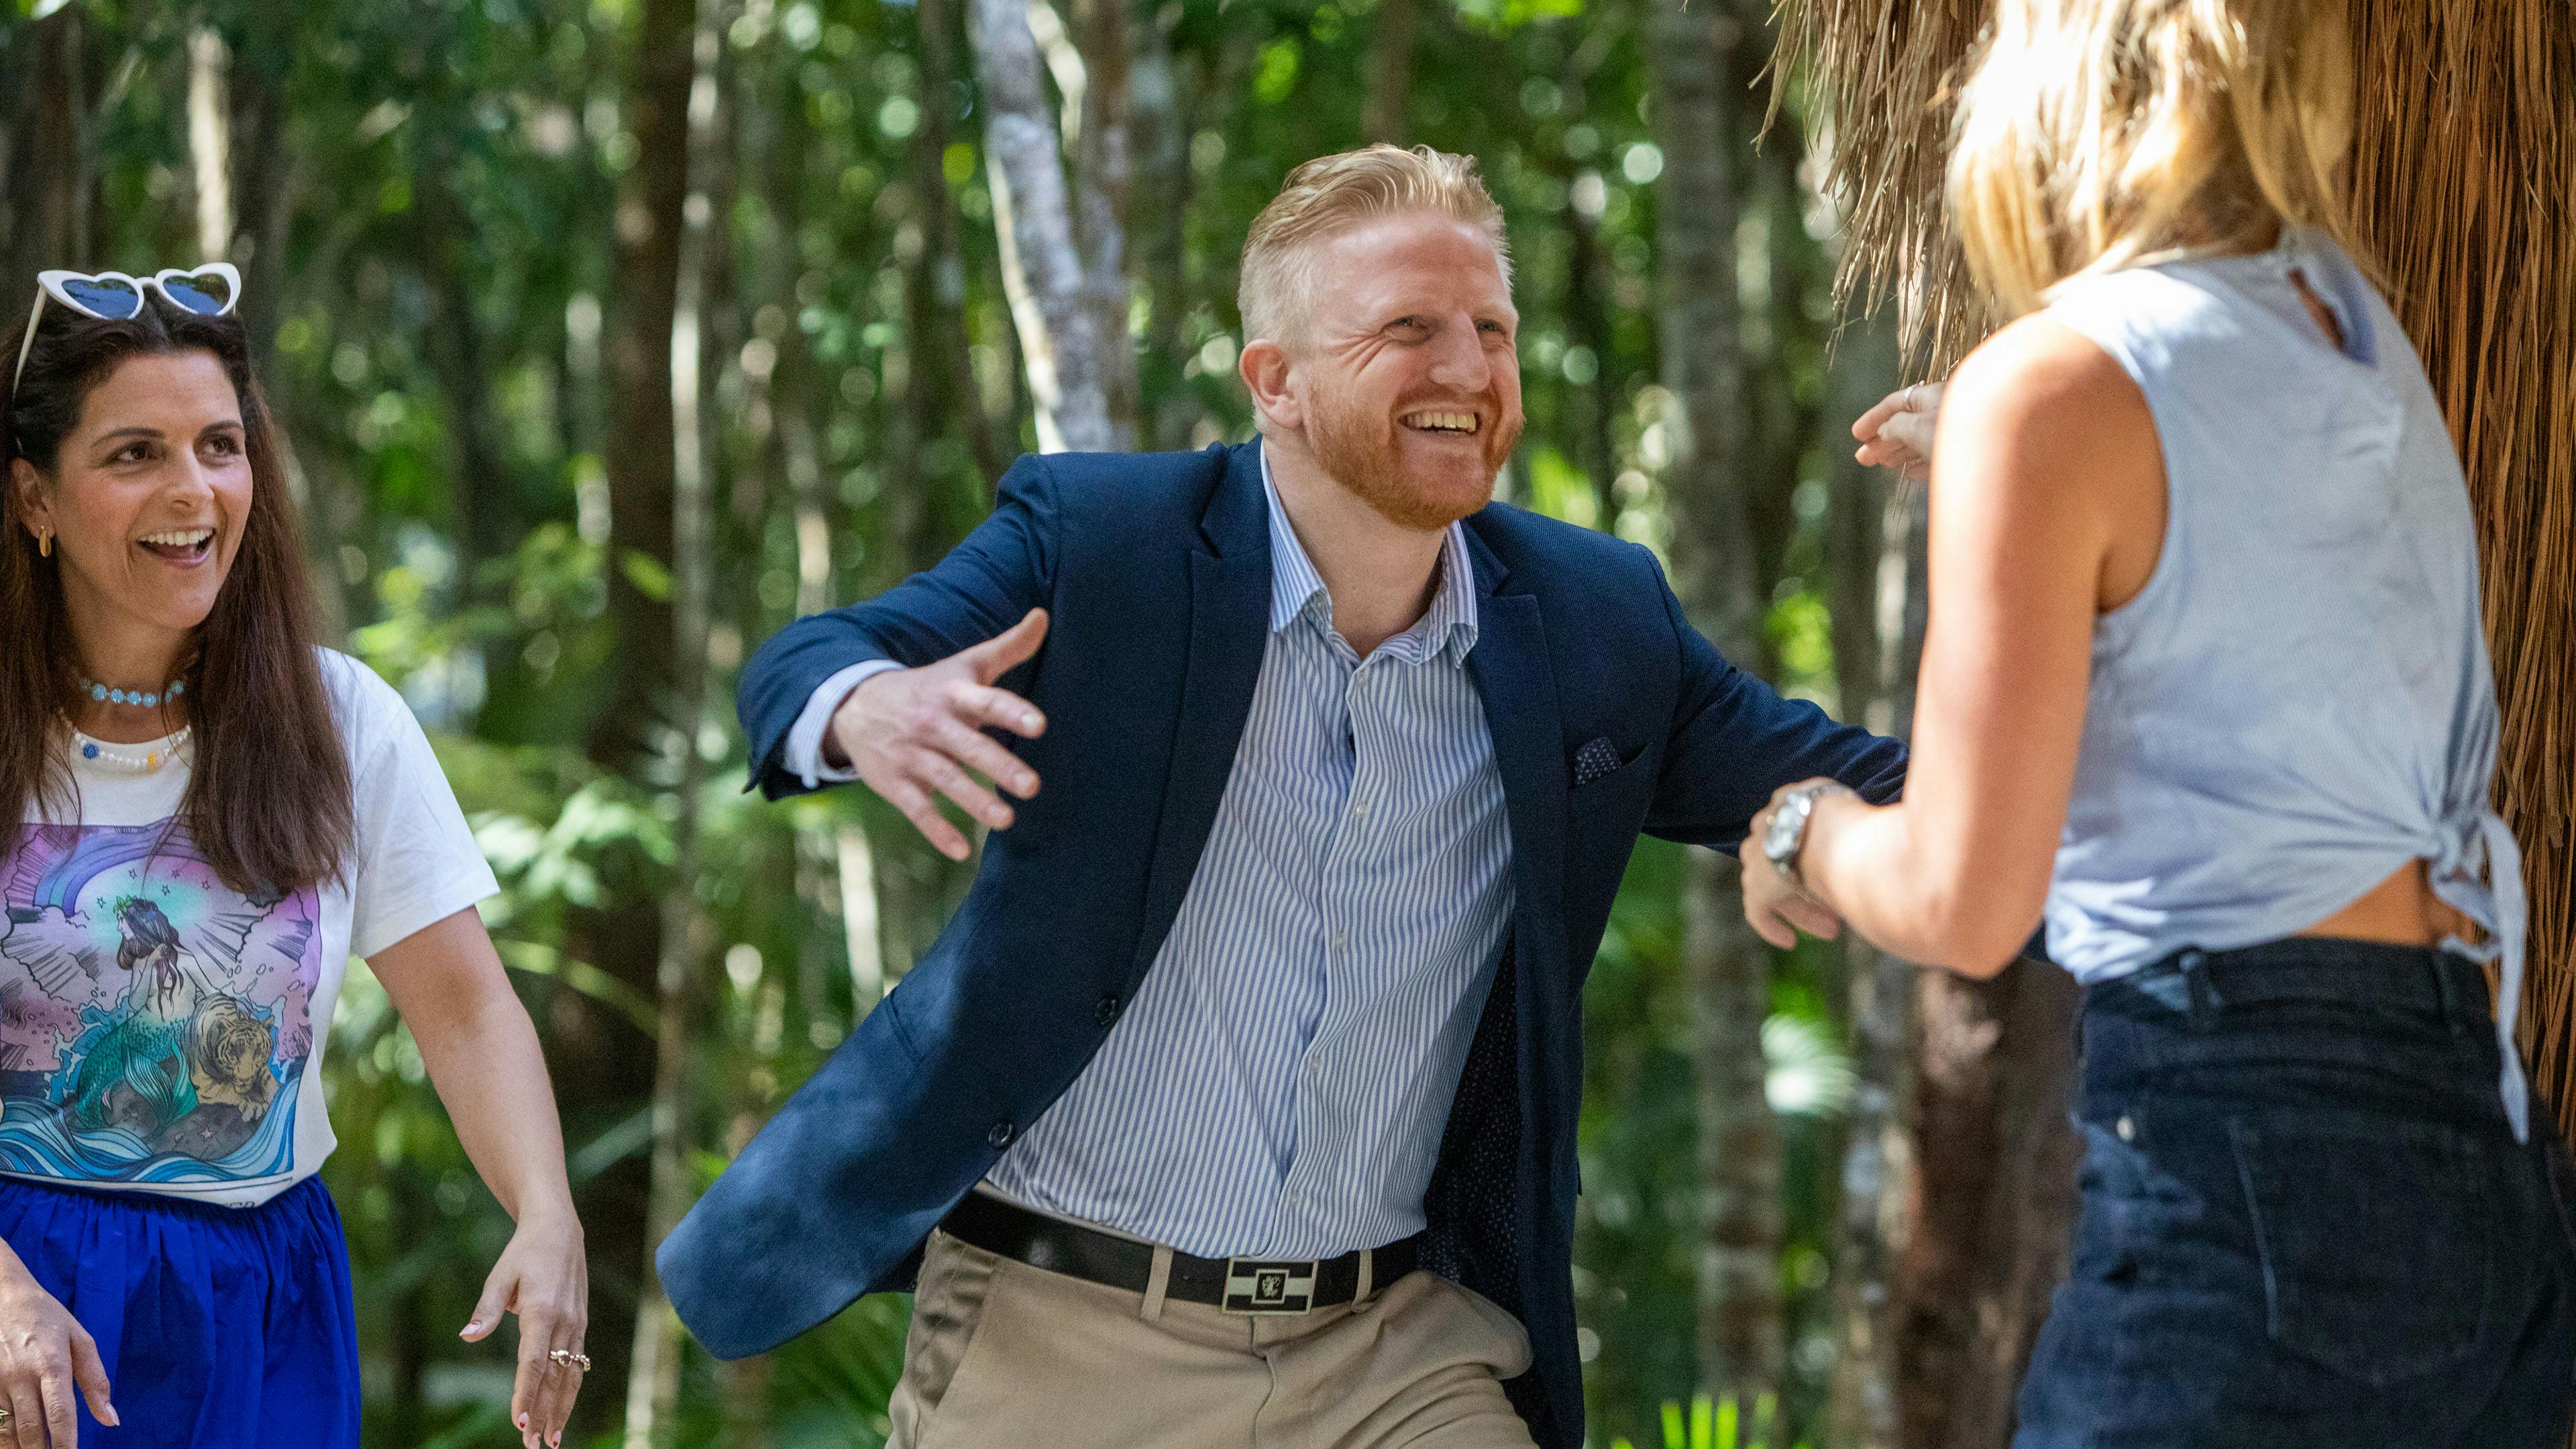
[0,0,2563,1449]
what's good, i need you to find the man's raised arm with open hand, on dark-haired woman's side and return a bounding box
[737,456,1056,814]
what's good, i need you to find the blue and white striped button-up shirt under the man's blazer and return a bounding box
[987,459,1512,1258]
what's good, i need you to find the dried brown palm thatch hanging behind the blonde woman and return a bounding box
[1775,0,2576,1127]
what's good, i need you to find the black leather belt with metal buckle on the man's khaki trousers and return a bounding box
[941,1191,1422,1315]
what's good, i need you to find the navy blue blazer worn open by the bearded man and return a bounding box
[657,443,1904,1449]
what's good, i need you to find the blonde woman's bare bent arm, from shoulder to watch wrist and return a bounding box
[1747,317,2164,975]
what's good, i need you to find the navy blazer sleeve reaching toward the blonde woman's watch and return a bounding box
[1646,549,1907,851]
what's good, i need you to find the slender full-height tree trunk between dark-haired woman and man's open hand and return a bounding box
[626,0,734,1449]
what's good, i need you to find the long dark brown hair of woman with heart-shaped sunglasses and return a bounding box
[0,294,353,892]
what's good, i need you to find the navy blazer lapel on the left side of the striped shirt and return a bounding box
[1128,443,1270,982]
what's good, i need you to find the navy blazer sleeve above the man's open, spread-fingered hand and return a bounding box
[734,453,1059,799]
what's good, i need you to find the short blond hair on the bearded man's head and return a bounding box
[1236,144,1512,343]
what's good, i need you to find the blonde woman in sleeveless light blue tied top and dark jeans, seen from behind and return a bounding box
[1744,0,2576,1449]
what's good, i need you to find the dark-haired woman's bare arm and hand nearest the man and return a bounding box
[368,908,590,1446]
